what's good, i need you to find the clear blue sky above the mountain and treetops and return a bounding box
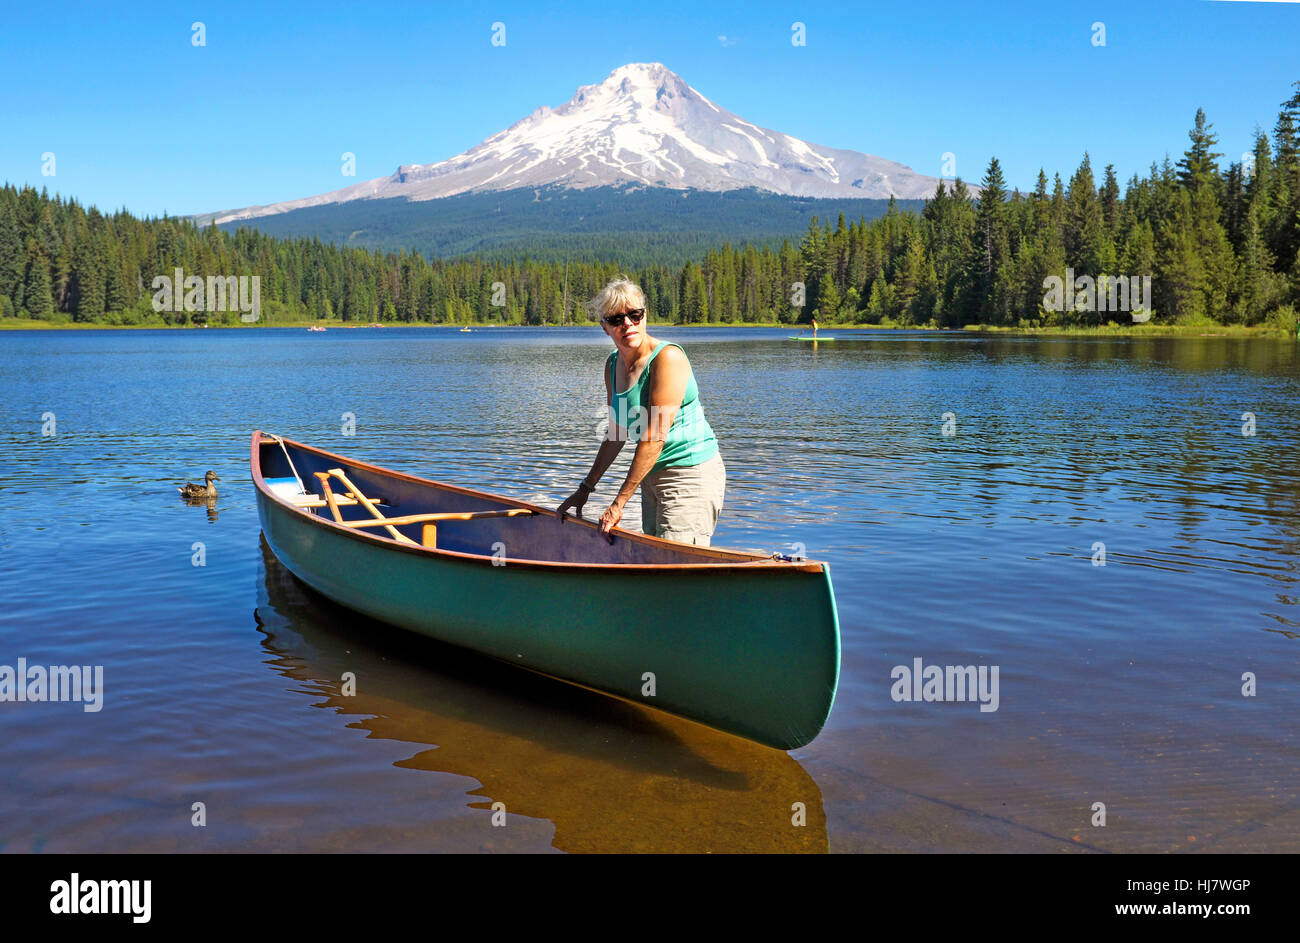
[0,0,1300,215]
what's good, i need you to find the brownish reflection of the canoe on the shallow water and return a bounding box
[254,541,827,852]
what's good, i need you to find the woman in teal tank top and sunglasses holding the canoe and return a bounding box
[556,278,727,546]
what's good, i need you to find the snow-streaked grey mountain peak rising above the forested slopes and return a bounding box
[205,62,956,224]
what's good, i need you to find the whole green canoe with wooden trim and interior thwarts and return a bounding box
[251,432,840,749]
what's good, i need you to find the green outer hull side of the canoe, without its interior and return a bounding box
[254,438,840,749]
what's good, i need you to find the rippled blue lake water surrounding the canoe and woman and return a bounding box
[0,325,1300,852]
